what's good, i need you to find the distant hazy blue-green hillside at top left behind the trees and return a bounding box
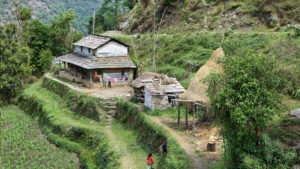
[0,0,103,33]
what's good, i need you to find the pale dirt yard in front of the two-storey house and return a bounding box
[45,74,133,99]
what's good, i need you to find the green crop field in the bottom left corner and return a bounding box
[0,105,80,169]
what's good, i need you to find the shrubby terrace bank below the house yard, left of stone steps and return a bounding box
[42,77,99,120]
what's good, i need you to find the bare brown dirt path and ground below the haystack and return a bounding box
[149,116,223,169]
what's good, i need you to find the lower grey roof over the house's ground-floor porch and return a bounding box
[57,52,136,69]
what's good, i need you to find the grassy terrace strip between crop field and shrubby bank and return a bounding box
[19,82,120,169]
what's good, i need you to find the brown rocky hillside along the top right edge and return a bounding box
[121,0,300,32]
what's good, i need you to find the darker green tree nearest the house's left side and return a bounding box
[28,11,82,76]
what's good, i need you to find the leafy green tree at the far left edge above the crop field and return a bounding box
[0,23,32,102]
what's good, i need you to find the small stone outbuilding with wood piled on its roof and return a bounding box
[131,72,185,110]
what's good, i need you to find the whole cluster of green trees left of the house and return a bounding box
[0,5,81,104]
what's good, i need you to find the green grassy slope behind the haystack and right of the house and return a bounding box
[112,30,300,91]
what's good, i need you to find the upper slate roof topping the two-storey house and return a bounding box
[73,35,129,49]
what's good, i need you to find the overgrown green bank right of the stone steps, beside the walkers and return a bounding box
[116,100,191,169]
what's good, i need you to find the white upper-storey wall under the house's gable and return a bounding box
[96,41,128,55]
